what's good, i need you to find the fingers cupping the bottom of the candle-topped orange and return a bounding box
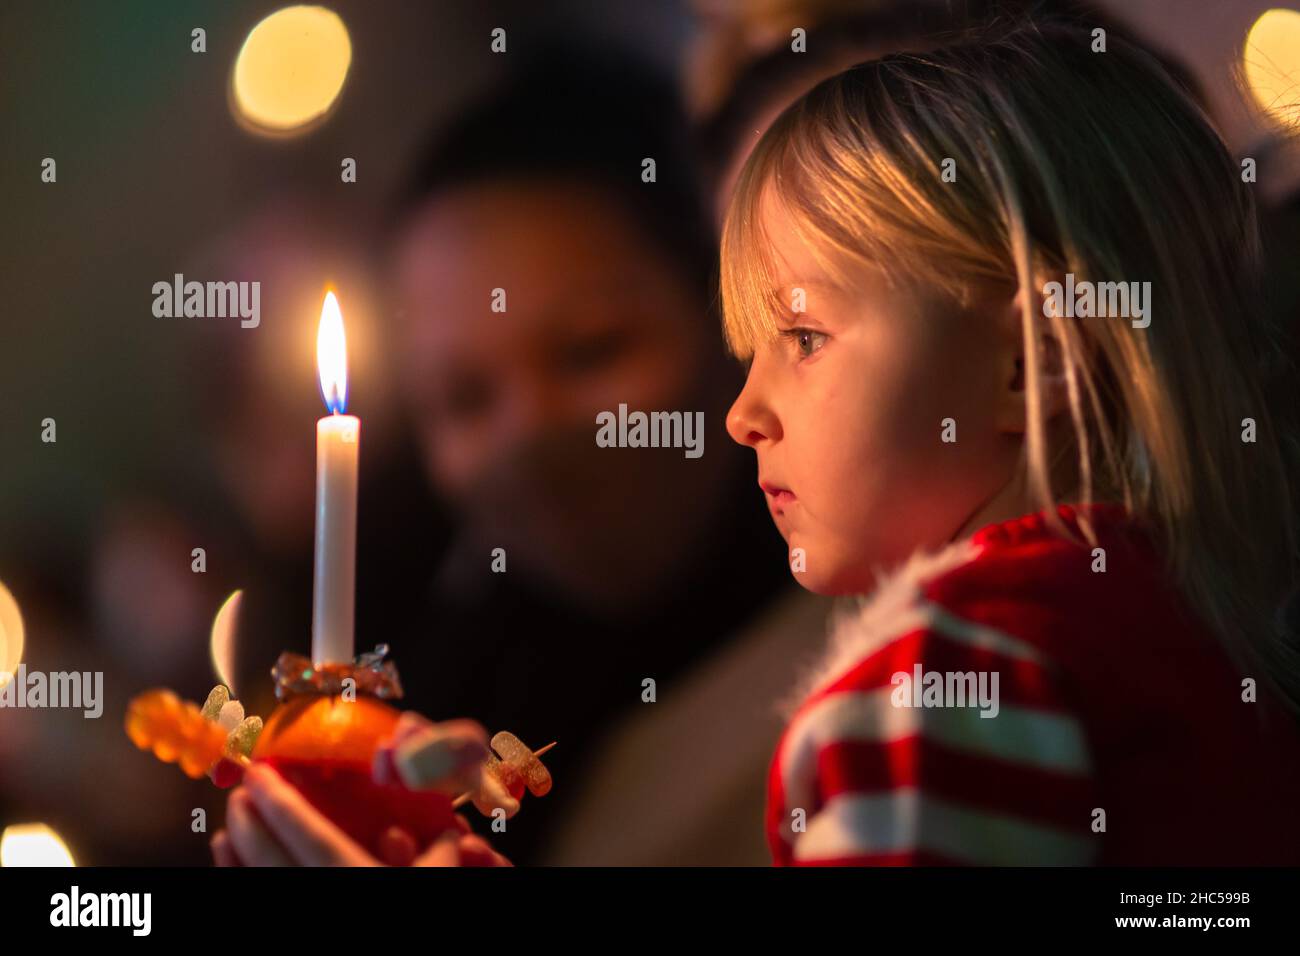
[212,763,511,866]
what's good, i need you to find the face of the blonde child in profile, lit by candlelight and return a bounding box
[727,191,1023,594]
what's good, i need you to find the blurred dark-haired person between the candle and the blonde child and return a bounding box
[379,51,824,864]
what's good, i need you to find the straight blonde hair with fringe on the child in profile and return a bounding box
[722,22,1300,711]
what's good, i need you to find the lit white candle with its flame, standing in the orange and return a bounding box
[312,293,361,665]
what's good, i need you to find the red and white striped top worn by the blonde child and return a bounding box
[767,506,1300,865]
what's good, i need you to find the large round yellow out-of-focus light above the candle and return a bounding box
[231,7,352,134]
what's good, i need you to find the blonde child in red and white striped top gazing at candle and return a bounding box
[722,16,1300,865]
